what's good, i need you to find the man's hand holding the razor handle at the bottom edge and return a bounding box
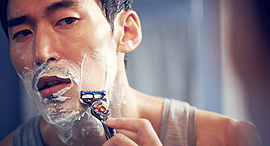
[103,118,162,146]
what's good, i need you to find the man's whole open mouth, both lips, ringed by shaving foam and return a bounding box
[37,76,71,99]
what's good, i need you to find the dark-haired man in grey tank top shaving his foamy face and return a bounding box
[1,0,259,146]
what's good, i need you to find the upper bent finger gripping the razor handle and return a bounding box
[106,118,161,146]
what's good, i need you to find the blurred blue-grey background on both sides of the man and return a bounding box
[0,0,270,145]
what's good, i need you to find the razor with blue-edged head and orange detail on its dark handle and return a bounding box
[81,91,116,140]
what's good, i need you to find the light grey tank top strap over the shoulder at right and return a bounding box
[159,98,196,146]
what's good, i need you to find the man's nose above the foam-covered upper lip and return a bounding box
[34,26,60,65]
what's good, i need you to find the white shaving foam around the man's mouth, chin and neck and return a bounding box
[19,55,108,144]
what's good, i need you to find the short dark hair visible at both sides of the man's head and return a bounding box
[0,0,133,37]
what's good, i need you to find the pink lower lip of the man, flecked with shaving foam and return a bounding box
[39,83,71,98]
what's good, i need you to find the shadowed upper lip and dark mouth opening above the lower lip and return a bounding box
[37,76,71,91]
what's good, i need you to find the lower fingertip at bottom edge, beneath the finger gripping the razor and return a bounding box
[102,133,138,146]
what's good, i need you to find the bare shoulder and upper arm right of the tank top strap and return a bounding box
[196,110,260,146]
